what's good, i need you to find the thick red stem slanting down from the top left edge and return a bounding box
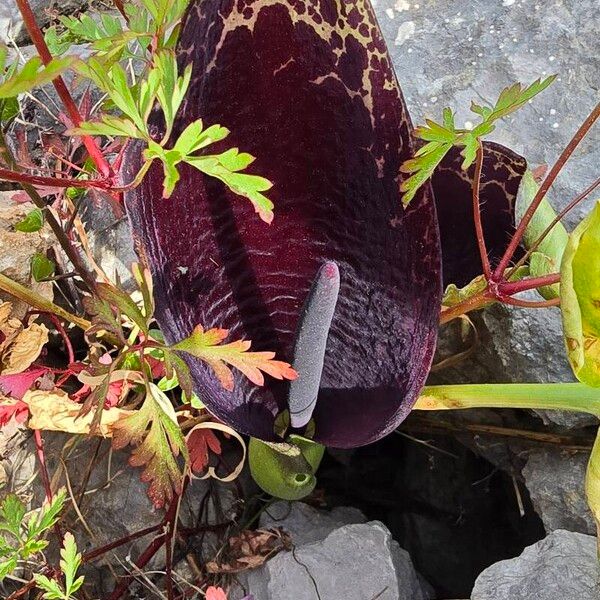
[16,0,114,178]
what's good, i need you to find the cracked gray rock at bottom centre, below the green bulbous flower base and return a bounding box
[227,502,432,600]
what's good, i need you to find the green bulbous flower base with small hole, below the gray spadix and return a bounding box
[248,435,325,500]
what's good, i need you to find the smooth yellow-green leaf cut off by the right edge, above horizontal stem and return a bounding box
[560,202,600,387]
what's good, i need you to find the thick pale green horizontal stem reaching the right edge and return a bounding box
[414,383,600,418]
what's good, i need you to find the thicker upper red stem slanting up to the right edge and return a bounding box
[493,103,600,281]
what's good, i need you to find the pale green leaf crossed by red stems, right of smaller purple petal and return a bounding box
[515,171,569,300]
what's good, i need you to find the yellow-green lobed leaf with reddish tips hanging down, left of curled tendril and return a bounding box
[113,383,188,507]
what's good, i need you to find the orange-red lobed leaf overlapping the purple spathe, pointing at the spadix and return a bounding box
[172,325,298,391]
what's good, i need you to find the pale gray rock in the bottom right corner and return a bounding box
[471,530,600,600]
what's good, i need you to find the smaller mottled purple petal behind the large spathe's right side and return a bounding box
[432,142,527,287]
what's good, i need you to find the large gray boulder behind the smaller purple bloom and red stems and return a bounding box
[374,0,600,427]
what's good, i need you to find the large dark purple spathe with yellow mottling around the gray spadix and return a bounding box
[126,0,441,447]
